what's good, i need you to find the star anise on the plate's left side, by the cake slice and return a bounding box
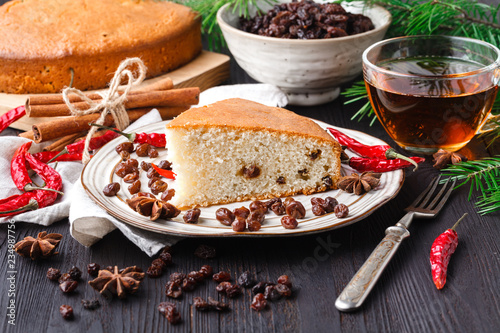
[127,196,181,221]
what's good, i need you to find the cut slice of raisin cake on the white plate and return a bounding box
[166,99,341,208]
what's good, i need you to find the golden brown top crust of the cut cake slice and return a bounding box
[167,98,337,143]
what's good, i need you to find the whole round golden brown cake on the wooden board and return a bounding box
[0,0,202,94]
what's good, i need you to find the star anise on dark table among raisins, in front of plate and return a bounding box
[89,266,144,298]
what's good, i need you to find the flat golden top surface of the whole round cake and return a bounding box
[0,0,198,60]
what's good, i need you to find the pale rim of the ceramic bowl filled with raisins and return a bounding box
[217,3,392,44]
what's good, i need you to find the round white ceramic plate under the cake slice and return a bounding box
[81,121,404,237]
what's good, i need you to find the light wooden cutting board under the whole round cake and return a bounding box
[0,51,229,131]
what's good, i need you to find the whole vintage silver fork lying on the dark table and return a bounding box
[335,176,456,311]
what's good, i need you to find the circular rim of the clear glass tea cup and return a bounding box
[362,35,500,79]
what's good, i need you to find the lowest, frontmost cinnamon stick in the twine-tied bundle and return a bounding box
[33,105,189,143]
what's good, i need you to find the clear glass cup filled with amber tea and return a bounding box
[363,36,500,154]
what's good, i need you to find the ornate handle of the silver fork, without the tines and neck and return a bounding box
[335,226,410,311]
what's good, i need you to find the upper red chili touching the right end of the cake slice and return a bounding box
[327,127,418,170]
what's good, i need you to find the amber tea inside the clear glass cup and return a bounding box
[367,58,497,151]
